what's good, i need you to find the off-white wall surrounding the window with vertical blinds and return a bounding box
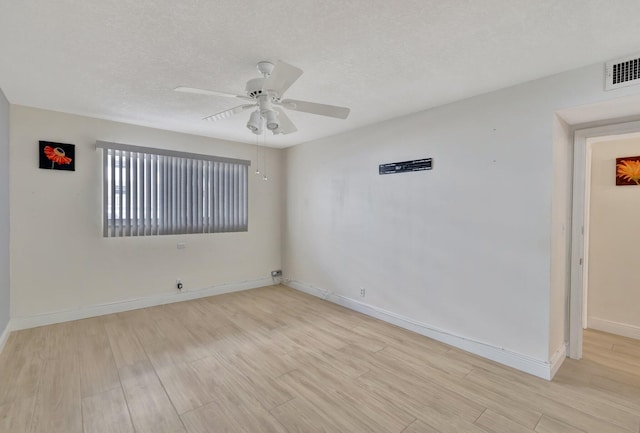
[10,105,282,318]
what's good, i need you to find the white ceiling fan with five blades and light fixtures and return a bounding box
[174,61,350,135]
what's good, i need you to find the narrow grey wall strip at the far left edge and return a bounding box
[0,89,10,338]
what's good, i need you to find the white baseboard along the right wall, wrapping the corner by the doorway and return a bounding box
[285,280,566,380]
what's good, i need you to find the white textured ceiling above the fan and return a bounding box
[0,0,640,147]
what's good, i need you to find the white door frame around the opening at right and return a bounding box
[569,121,640,359]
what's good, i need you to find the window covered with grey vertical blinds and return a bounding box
[96,141,249,237]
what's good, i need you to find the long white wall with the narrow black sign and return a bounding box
[284,60,638,368]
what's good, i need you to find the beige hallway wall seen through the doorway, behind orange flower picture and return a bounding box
[587,136,640,338]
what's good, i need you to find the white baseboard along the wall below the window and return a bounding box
[11,278,273,331]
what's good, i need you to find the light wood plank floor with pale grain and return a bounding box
[0,286,640,433]
